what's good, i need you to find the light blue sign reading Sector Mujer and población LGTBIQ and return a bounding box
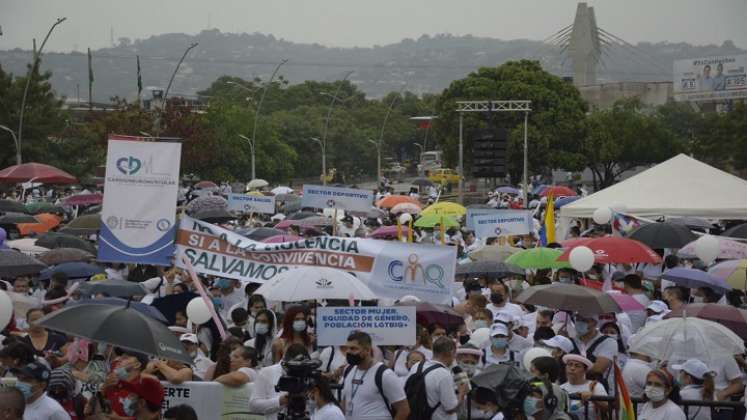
[316,306,415,346]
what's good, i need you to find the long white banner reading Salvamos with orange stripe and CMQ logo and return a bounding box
[176,217,456,304]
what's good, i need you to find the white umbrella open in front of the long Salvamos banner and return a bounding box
[254,267,376,302]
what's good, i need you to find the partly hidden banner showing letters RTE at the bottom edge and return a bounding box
[161,381,264,420]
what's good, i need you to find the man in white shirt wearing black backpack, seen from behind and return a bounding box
[410,337,468,420]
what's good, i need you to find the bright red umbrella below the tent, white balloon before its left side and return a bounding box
[558,236,661,264]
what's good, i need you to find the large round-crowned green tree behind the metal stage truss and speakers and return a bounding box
[435,60,587,181]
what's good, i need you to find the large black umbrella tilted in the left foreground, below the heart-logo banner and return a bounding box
[39,303,192,365]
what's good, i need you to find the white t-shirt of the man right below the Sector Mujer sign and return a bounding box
[342,363,407,420]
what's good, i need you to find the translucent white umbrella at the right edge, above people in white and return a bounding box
[630,317,744,366]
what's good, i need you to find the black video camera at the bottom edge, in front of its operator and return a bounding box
[275,356,322,420]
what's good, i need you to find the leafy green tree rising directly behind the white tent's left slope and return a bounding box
[582,99,684,189]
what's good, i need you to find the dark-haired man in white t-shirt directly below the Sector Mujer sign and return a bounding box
[341,331,410,420]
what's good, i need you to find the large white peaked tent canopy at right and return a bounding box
[560,154,747,219]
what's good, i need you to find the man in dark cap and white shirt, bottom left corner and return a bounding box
[11,362,70,420]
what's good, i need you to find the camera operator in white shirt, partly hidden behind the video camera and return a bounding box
[249,343,309,420]
